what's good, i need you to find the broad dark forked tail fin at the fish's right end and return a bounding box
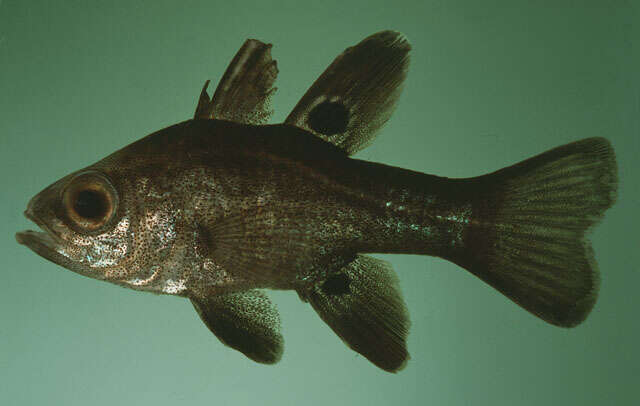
[448,138,617,327]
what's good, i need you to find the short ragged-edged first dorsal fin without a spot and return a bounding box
[194,39,278,125]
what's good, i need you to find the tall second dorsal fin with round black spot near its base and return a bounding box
[285,31,411,155]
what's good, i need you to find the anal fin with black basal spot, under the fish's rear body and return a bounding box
[298,255,410,372]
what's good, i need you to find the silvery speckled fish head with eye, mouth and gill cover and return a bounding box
[16,121,240,296]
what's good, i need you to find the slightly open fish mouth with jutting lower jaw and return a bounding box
[16,209,69,268]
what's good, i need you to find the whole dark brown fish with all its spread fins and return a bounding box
[16,31,617,372]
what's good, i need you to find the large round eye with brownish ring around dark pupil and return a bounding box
[62,171,118,231]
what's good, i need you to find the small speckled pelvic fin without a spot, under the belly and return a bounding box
[191,290,283,364]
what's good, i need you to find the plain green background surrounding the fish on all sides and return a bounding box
[0,0,640,405]
